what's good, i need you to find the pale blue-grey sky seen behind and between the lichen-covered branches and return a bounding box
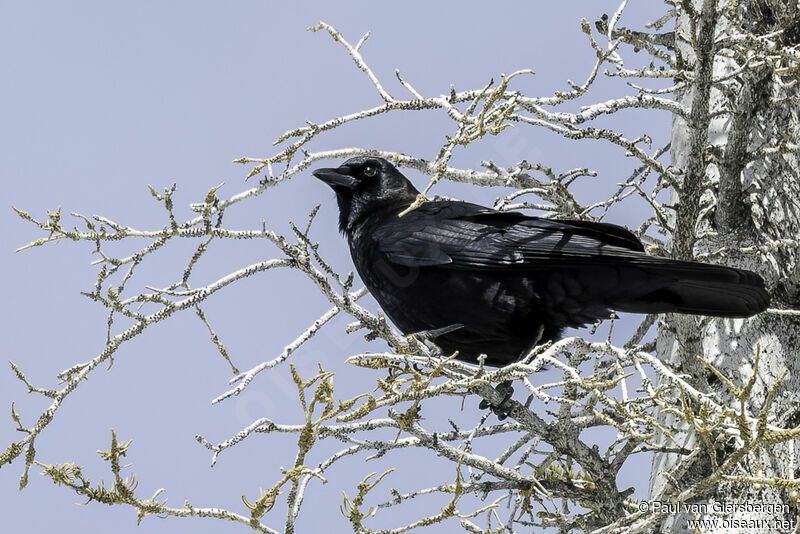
[0,0,670,533]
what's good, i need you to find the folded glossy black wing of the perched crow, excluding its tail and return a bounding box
[373,201,649,270]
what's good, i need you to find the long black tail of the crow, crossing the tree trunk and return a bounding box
[611,257,770,317]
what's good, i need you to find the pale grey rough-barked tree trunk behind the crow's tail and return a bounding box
[650,0,800,532]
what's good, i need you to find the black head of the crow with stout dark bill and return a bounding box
[313,156,419,233]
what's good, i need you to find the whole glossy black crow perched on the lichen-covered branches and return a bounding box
[314,157,769,365]
